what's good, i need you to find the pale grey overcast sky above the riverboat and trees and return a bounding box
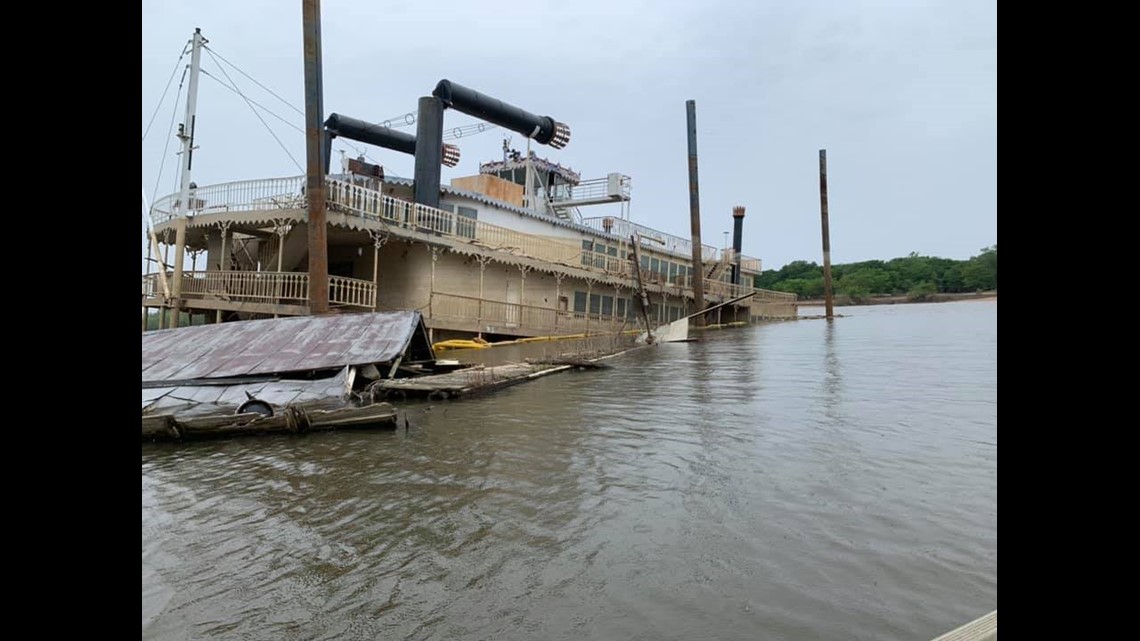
[141,0,998,269]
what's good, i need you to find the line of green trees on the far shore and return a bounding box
[754,244,998,302]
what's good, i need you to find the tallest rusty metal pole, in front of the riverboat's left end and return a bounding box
[300,0,328,316]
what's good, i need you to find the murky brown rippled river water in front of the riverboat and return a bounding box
[143,302,998,641]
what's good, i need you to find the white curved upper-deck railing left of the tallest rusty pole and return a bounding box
[150,176,304,225]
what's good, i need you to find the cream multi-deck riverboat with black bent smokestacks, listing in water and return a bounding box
[143,32,796,341]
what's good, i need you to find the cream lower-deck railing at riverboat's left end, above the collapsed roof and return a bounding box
[143,270,376,309]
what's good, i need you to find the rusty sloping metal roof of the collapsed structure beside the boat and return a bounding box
[143,311,423,382]
